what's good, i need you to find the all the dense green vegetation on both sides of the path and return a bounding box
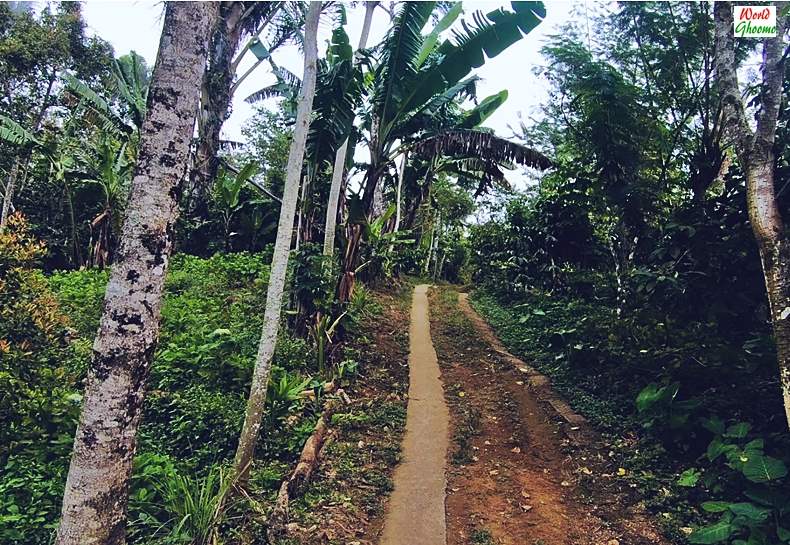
[6,2,790,545]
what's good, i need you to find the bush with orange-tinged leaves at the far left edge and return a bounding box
[0,214,84,544]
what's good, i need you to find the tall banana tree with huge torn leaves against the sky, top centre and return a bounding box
[338,2,545,301]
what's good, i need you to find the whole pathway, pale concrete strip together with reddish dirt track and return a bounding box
[380,286,664,545]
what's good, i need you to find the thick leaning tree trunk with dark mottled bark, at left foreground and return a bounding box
[55,2,218,545]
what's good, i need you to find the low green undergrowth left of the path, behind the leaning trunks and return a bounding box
[0,223,384,543]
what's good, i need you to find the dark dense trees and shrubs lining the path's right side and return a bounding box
[470,4,790,544]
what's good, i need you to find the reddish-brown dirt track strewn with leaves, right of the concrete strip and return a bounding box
[431,289,662,545]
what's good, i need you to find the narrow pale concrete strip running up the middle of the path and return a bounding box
[380,285,450,545]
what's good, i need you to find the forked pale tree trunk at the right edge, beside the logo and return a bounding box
[714,2,790,426]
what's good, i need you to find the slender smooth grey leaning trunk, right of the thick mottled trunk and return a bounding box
[234,2,321,480]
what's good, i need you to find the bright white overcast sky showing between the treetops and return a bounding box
[83,0,572,144]
